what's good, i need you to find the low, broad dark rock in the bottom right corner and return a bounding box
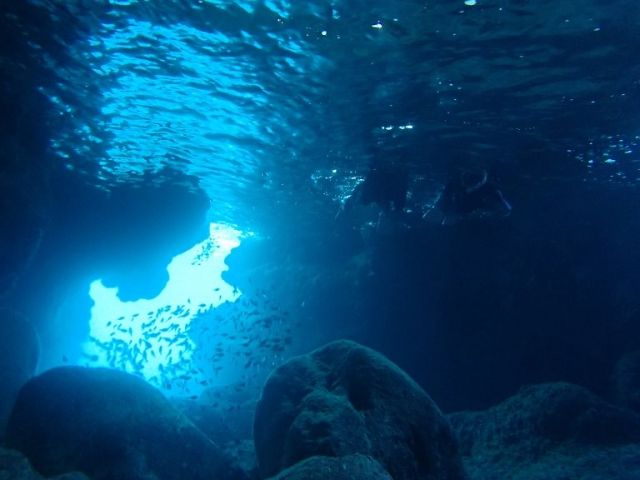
[449,383,640,480]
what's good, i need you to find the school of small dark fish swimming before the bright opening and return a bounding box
[84,289,300,399]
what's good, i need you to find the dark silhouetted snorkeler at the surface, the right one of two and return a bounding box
[432,169,512,225]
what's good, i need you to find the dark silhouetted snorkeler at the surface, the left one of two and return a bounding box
[343,162,409,213]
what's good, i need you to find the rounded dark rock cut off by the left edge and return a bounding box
[0,309,40,441]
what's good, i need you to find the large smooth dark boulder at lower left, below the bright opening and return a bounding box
[6,367,245,480]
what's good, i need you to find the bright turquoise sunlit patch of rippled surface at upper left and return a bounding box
[95,18,270,190]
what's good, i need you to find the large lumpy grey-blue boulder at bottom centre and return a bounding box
[254,340,464,480]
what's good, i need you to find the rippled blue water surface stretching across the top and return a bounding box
[5,0,640,231]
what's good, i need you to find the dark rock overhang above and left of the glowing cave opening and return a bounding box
[9,167,209,358]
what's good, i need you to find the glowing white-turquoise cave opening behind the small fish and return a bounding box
[84,223,242,392]
